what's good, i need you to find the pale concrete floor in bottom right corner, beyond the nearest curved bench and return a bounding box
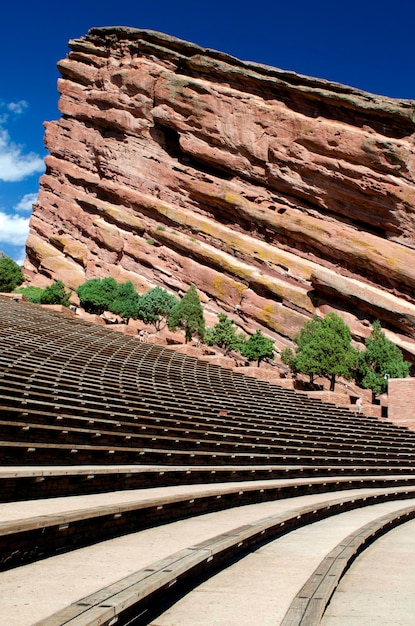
[321,521,415,626]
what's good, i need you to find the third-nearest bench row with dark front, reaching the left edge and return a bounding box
[0,476,415,570]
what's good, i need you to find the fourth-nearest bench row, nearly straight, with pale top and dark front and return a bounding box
[0,465,415,502]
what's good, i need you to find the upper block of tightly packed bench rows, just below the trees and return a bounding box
[0,301,415,464]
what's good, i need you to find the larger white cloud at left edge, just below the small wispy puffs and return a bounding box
[0,129,45,182]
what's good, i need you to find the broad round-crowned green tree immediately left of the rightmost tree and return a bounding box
[287,313,357,391]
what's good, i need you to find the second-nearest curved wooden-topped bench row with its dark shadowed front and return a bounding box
[30,492,415,626]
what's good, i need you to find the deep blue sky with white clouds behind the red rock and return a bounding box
[0,0,415,261]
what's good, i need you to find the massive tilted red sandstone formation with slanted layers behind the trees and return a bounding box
[26,27,415,352]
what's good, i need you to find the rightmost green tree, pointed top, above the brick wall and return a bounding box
[356,320,411,399]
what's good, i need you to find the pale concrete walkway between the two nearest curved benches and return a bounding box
[151,500,415,626]
